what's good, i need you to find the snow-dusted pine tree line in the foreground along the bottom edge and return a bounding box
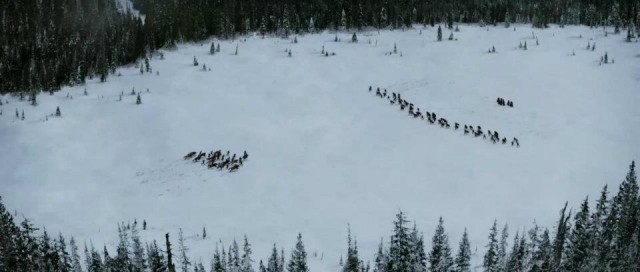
[0,160,640,272]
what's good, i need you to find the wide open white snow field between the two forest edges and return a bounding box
[0,25,640,271]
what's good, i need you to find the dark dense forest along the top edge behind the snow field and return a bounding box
[0,0,640,96]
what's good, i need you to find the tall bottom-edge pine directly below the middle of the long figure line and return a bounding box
[429,217,453,272]
